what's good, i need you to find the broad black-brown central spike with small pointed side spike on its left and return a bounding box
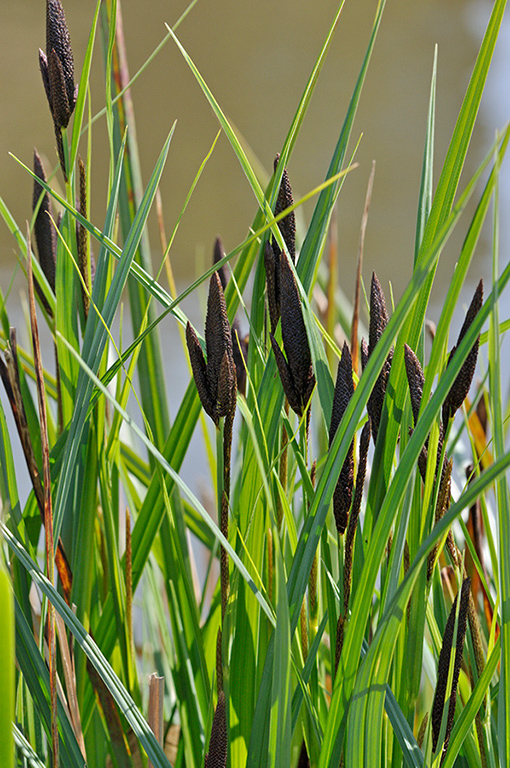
[271,254,315,418]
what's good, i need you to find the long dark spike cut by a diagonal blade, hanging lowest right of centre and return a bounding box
[329,342,354,534]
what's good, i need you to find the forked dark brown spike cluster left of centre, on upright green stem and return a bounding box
[186,272,237,426]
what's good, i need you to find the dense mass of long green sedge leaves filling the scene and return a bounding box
[0,0,510,768]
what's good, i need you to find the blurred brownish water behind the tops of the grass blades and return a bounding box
[0,0,510,492]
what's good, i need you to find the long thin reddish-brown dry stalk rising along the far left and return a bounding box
[27,223,59,767]
